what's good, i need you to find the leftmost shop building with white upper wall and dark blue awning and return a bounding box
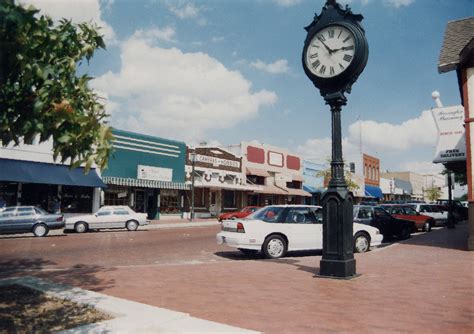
[0,140,105,214]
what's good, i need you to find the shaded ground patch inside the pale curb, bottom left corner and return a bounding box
[0,284,112,333]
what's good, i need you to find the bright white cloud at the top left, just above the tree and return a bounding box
[19,0,116,45]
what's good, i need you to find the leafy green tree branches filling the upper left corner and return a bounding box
[0,0,113,171]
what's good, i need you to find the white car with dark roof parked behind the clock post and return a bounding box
[216,205,383,259]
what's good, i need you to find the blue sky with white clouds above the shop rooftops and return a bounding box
[22,0,474,172]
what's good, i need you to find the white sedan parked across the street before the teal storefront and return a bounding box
[64,206,149,233]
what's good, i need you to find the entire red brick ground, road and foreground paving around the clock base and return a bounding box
[0,224,474,333]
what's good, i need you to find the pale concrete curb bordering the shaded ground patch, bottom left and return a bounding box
[0,276,259,334]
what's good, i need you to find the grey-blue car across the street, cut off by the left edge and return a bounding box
[0,206,64,237]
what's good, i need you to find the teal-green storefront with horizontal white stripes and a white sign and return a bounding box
[103,129,189,219]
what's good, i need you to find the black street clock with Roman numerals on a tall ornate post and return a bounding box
[303,0,368,279]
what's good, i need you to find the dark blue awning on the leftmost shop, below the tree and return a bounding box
[0,159,106,188]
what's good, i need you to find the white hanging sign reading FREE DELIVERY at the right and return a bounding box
[431,106,466,163]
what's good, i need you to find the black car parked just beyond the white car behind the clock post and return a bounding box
[354,205,416,239]
